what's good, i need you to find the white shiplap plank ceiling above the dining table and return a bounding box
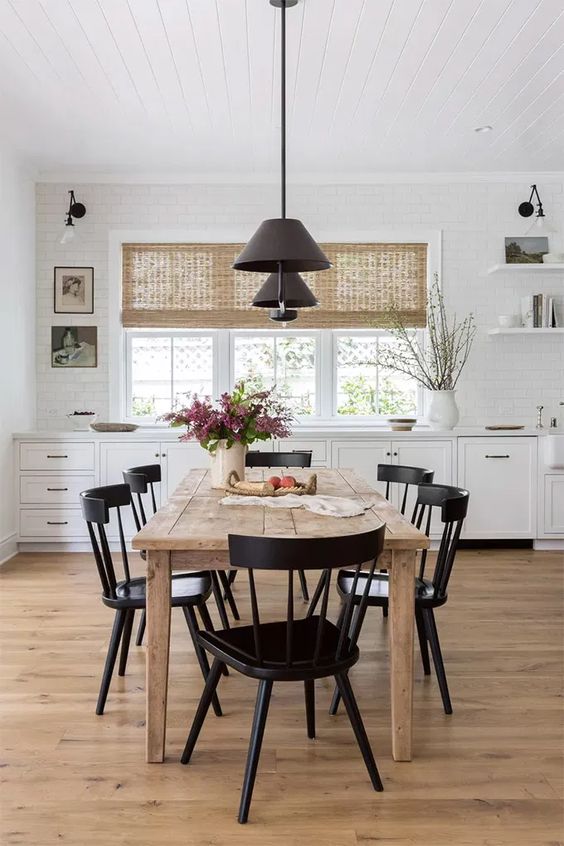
[0,0,564,176]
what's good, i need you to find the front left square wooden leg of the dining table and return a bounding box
[145,550,171,763]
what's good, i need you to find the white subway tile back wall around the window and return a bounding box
[37,177,564,430]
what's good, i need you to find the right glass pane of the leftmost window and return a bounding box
[172,335,213,407]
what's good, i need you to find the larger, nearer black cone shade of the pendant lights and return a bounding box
[233,218,331,272]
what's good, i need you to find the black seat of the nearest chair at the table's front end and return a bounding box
[198,616,359,681]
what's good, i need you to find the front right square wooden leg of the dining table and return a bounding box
[388,549,417,761]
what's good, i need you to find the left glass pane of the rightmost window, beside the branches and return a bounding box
[337,335,378,416]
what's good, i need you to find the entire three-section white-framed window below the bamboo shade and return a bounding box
[125,329,422,423]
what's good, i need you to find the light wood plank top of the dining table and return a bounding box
[132,468,429,552]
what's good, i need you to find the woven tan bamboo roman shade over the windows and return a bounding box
[122,244,427,329]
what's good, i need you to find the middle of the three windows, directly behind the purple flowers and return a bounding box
[233,332,318,416]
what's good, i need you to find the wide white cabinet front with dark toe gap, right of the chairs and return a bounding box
[458,437,537,538]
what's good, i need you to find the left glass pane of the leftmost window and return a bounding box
[129,336,171,417]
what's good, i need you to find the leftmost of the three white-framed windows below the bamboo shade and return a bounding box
[127,331,215,420]
